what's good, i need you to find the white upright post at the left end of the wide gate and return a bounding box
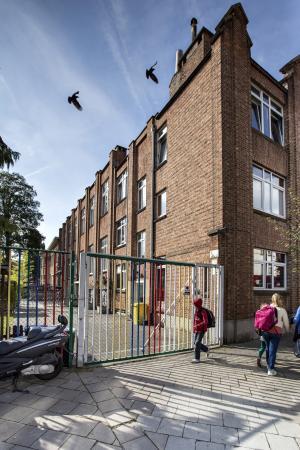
[77,252,88,367]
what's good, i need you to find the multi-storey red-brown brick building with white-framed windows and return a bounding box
[52,4,300,341]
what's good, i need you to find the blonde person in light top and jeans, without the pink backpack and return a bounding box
[262,293,290,376]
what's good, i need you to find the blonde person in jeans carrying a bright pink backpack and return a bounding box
[255,294,290,376]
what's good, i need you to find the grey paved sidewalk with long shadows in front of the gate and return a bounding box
[0,342,300,450]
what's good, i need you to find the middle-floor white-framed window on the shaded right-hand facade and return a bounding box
[252,165,285,218]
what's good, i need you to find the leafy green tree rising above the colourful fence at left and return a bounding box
[0,171,44,248]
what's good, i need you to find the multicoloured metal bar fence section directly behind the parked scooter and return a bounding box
[0,247,73,339]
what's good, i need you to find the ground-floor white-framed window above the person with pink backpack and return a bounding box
[253,248,287,291]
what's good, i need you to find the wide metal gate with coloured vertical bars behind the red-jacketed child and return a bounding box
[74,253,223,366]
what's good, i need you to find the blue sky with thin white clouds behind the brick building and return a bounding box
[0,0,300,245]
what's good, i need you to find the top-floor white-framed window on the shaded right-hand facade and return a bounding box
[251,85,284,145]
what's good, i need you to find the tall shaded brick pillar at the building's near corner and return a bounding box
[216,4,254,342]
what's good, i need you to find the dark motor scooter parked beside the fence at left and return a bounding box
[0,316,69,391]
